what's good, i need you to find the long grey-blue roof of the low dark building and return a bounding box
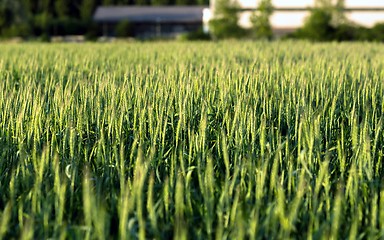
[93,6,208,23]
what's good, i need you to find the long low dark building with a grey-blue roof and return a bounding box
[93,6,207,39]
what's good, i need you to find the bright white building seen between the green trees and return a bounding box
[206,0,384,32]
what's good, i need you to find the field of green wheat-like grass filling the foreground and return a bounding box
[0,42,384,239]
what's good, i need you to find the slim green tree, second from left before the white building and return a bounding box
[251,0,273,39]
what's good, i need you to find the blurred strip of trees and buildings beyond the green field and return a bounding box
[0,0,384,42]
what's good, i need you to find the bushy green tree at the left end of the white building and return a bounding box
[209,0,245,39]
